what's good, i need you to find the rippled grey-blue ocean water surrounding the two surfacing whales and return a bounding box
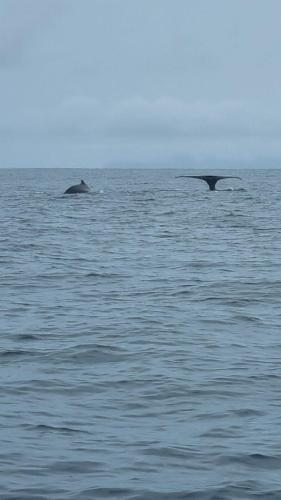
[0,169,281,500]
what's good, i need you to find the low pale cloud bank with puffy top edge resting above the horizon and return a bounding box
[0,96,281,166]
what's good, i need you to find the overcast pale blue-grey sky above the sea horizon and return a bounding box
[0,0,281,169]
